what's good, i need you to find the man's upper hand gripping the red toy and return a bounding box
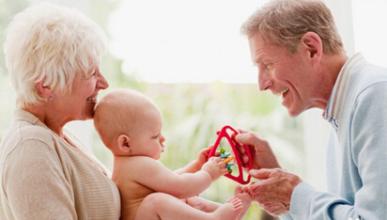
[235,130,280,169]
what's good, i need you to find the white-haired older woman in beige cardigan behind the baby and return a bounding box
[0,4,120,220]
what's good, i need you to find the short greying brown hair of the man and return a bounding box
[241,0,343,54]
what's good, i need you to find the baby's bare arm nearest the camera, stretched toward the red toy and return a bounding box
[130,157,227,198]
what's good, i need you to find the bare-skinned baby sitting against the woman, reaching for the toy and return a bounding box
[94,90,251,220]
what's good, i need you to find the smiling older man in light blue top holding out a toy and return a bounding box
[237,0,387,220]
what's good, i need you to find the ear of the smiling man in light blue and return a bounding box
[301,32,323,60]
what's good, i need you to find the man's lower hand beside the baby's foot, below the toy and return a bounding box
[243,168,301,216]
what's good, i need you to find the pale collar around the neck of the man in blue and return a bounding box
[323,53,364,129]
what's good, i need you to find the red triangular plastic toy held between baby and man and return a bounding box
[209,125,253,184]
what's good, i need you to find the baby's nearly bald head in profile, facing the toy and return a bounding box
[94,89,165,159]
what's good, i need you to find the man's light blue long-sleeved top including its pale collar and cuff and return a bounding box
[283,54,387,220]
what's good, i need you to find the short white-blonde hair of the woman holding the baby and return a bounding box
[4,3,106,107]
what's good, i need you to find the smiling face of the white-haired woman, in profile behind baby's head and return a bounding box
[55,66,109,121]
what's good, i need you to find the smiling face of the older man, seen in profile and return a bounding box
[249,34,319,116]
